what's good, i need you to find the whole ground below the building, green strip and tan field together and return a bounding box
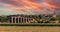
[0,23,60,32]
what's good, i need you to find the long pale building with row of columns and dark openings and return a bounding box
[10,16,35,23]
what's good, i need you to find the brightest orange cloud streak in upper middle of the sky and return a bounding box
[1,0,43,12]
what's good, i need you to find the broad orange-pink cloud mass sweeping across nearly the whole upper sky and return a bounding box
[0,0,60,14]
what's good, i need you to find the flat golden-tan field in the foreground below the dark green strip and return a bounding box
[0,26,60,32]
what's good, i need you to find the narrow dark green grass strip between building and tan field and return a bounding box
[0,23,60,26]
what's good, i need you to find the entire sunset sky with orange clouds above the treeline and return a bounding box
[0,0,60,15]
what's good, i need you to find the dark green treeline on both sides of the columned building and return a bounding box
[0,15,60,23]
